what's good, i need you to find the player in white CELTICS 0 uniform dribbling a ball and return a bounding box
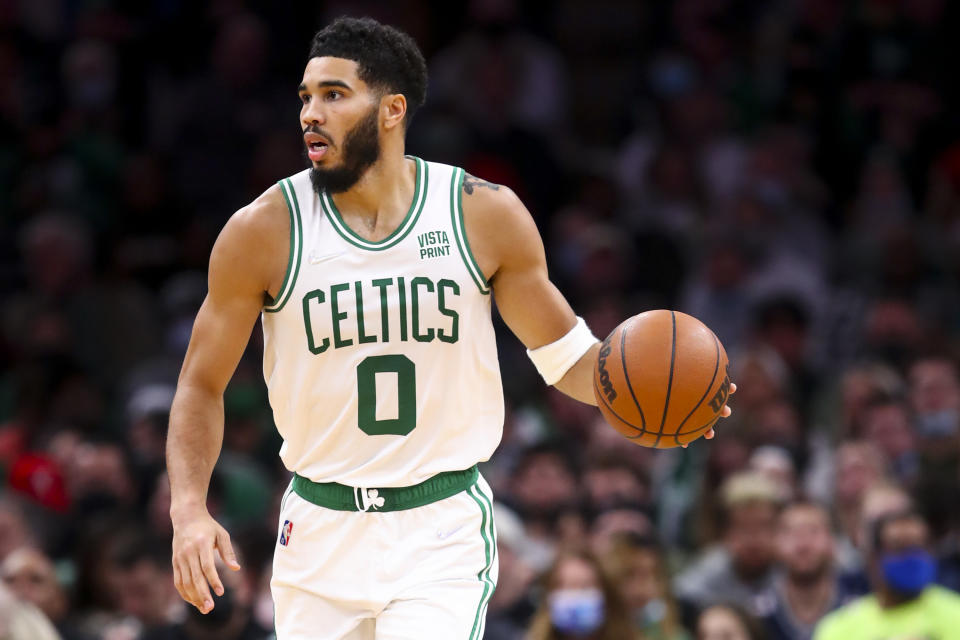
[167,19,729,640]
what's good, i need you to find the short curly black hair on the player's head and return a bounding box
[308,16,427,126]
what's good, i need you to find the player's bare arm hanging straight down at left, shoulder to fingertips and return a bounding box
[167,187,289,613]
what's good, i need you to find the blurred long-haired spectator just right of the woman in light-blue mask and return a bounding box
[601,533,690,640]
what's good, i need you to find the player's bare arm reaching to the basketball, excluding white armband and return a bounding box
[462,175,600,405]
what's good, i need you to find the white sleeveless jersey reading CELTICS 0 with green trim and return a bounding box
[262,158,503,487]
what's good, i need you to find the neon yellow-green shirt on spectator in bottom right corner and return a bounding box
[813,586,960,640]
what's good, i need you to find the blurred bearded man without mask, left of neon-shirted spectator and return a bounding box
[764,501,845,640]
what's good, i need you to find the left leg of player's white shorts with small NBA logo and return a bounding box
[270,484,380,640]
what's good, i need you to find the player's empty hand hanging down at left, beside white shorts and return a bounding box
[173,508,240,613]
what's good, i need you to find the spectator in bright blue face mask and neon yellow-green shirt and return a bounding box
[813,510,960,640]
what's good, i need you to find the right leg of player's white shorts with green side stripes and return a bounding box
[376,477,498,640]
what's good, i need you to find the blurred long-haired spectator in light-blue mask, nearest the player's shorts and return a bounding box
[526,552,639,640]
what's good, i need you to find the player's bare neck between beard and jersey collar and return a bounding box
[333,144,416,220]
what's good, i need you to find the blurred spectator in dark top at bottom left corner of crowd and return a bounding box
[0,547,89,640]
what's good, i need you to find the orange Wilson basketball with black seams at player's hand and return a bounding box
[593,309,730,449]
